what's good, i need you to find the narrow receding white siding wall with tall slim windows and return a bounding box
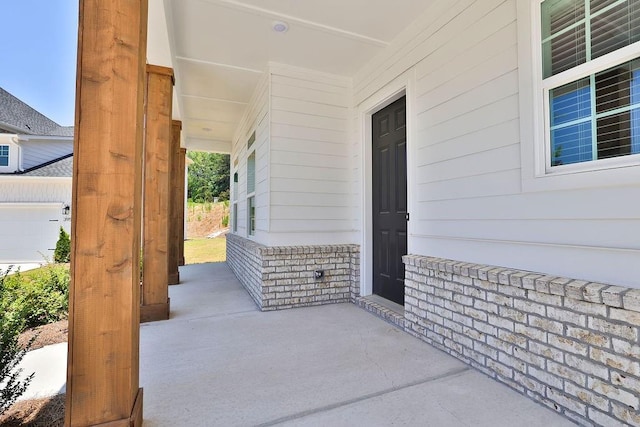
[231,75,269,244]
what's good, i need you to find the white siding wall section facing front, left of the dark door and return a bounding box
[269,64,357,246]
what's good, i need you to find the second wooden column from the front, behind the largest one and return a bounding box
[140,65,173,322]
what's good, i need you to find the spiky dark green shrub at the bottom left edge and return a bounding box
[0,268,34,415]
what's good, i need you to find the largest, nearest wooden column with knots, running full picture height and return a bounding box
[65,0,147,426]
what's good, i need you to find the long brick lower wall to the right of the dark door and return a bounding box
[403,256,640,426]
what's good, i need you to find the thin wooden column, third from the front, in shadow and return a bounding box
[169,120,184,285]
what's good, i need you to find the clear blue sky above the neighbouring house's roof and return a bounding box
[0,0,79,126]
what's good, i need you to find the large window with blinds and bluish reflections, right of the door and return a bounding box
[541,0,640,171]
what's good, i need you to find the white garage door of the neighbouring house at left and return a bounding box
[0,203,63,264]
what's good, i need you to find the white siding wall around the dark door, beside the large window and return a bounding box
[353,0,640,287]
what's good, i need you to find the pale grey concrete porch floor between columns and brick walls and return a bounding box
[140,263,572,427]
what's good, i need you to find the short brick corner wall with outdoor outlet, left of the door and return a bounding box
[227,234,360,310]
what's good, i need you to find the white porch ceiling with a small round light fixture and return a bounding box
[147,0,431,152]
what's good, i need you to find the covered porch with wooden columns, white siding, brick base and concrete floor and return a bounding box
[66,0,640,427]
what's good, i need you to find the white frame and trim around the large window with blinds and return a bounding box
[517,0,640,191]
